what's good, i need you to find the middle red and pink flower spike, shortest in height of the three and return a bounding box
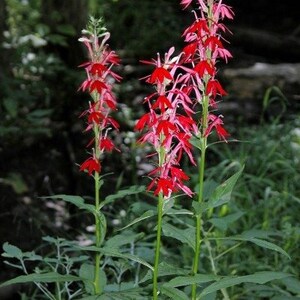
[135,48,197,197]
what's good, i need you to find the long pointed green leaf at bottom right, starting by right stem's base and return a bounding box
[198,272,291,299]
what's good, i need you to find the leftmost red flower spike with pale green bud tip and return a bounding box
[79,20,121,175]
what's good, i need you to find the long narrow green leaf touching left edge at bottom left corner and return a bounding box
[0,272,82,287]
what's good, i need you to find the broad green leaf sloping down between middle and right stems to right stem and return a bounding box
[162,223,195,250]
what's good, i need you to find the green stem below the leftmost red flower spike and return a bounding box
[94,172,101,295]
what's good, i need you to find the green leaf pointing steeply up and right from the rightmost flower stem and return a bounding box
[205,166,244,209]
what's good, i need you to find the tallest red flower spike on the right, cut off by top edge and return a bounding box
[181,0,234,141]
